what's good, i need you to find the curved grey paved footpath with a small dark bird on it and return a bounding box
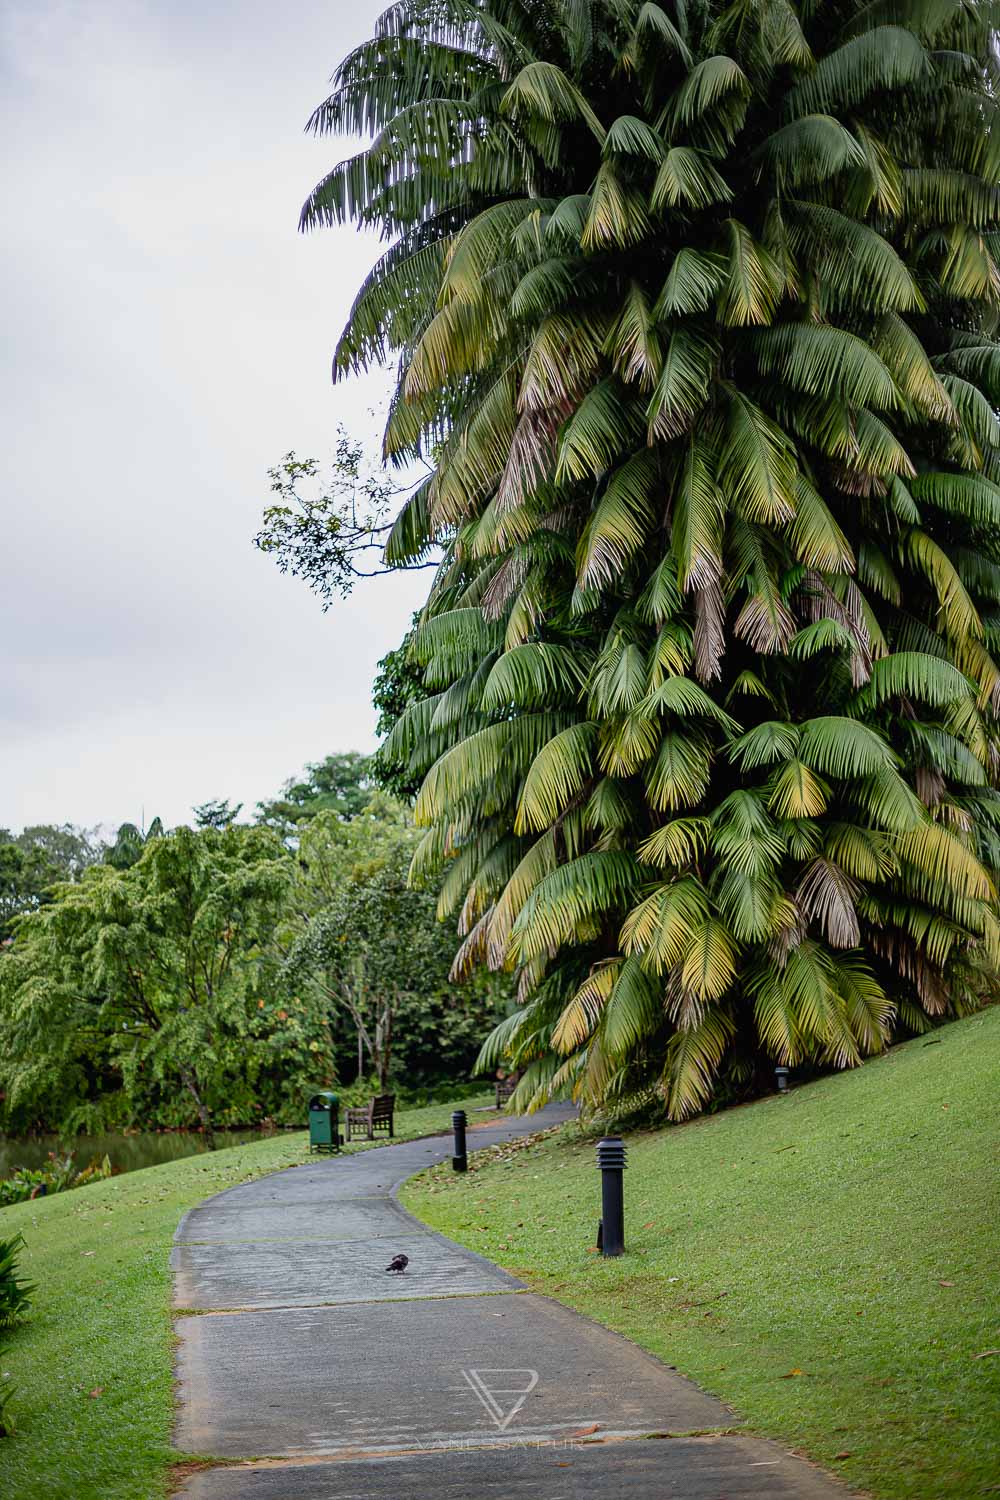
[172,1106,847,1500]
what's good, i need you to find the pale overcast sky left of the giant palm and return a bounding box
[0,0,427,828]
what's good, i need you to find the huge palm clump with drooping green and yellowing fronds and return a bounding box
[303,0,1000,1118]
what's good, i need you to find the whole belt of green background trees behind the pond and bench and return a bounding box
[0,780,510,1134]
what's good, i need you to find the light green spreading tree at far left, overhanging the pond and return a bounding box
[0,828,299,1140]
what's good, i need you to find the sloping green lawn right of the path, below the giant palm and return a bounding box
[403,1008,1000,1500]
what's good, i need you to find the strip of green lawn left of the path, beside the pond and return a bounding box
[0,1097,487,1500]
